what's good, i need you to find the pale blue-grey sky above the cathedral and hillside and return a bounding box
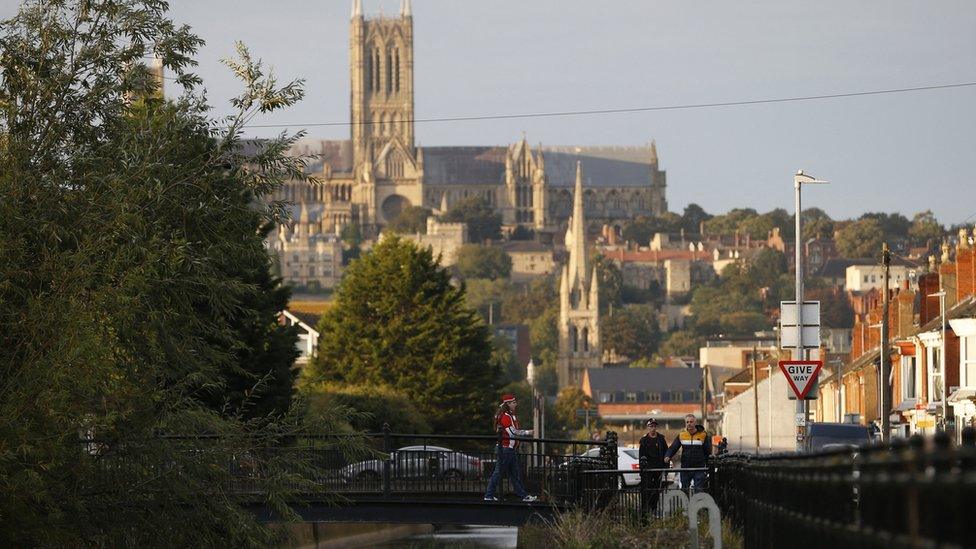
[0,0,976,224]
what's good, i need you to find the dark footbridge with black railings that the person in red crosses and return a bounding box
[85,432,688,526]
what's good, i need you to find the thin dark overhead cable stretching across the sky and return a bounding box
[238,82,976,128]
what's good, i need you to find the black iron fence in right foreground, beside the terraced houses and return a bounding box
[712,436,976,548]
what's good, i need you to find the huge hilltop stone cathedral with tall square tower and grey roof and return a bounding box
[275,0,667,238]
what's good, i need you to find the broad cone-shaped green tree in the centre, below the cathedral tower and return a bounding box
[308,236,500,433]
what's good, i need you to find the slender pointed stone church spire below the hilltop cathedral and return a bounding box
[556,162,603,388]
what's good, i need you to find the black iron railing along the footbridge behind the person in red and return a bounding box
[82,432,617,505]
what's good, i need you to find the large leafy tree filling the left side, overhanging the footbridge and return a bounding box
[0,0,355,547]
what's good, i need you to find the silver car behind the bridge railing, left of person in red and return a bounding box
[341,446,481,481]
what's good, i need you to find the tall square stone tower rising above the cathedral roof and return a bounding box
[349,0,414,169]
